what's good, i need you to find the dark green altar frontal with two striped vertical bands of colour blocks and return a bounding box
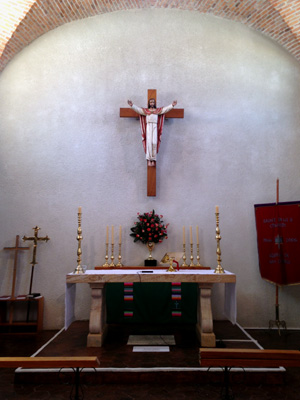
[106,282,198,324]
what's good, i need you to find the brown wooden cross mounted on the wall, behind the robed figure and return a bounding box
[120,89,184,196]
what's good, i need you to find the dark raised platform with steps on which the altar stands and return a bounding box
[15,321,285,384]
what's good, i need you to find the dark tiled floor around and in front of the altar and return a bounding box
[0,321,300,400]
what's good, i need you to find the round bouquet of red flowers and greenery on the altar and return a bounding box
[130,210,169,244]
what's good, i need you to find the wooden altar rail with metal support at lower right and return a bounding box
[199,348,300,400]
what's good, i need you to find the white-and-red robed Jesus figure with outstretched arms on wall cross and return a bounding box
[128,99,177,167]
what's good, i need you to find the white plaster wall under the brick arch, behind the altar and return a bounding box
[0,9,300,329]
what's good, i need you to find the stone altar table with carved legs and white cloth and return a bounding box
[65,267,236,347]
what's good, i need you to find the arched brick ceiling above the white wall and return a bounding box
[0,0,300,71]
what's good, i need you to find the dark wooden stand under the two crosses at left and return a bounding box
[0,295,44,333]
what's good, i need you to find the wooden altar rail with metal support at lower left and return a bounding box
[0,357,100,400]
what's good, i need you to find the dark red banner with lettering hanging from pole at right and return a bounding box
[254,202,300,285]
